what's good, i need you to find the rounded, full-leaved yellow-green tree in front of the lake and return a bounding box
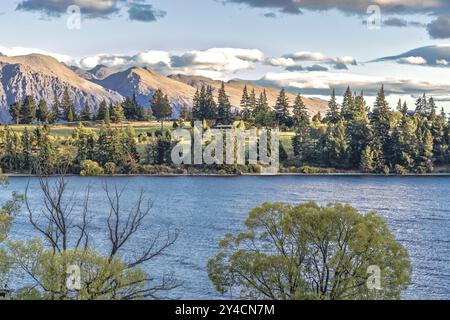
[208,202,411,300]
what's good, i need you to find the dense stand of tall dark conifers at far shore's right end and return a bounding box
[292,87,450,174]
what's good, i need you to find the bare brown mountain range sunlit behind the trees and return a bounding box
[0,54,327,122]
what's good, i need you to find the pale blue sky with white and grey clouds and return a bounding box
[0,0,450,112]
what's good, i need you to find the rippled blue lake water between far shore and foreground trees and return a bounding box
[0,176,450,299]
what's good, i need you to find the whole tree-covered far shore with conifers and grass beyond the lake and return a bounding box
[0,84,450,175]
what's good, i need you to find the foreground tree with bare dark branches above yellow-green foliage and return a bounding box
[6,177,179,300]
